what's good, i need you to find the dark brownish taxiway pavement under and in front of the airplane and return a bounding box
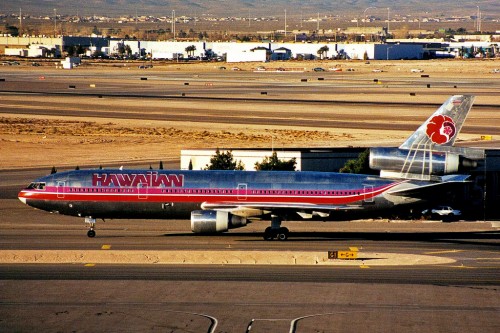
[0,199,500,333]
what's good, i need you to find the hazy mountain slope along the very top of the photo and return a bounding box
[0,0,500,18]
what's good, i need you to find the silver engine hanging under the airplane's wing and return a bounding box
[191,210,247,234]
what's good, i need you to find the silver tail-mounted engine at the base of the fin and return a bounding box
[370,148,477,176]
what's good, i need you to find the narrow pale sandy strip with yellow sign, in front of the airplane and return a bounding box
[0,245,455,266]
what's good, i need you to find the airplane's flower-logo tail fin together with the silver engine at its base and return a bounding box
[370,95,484,181]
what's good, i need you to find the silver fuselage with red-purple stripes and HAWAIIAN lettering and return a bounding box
[19,170,402,218]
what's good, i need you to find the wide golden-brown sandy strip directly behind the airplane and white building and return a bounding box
[0,116,378,169]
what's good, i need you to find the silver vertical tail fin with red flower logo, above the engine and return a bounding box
[399,95,474,150]
